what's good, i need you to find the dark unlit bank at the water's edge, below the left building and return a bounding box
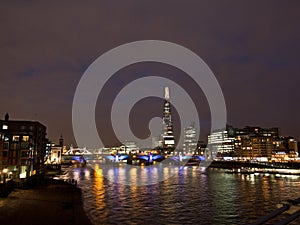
[0,180,91,225]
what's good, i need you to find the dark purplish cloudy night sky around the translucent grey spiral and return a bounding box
[0,0,300,146]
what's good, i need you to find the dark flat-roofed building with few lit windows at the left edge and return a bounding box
[0,114,47,178]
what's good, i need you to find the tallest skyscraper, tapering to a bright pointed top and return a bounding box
[162,87,175,152]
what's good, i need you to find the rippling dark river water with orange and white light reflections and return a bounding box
[63,164,300,225]
